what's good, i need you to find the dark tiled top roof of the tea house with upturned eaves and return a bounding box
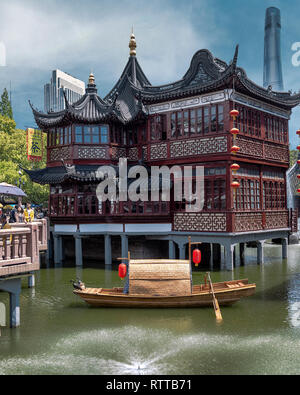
[31,46,300,129]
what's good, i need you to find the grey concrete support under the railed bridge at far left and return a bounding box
[0,278,21,328]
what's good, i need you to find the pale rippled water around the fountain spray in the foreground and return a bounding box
[0,327,300,375]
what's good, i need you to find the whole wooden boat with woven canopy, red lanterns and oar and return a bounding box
[73,237,256,314]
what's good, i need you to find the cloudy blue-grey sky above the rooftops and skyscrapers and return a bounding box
[0,0,300,148]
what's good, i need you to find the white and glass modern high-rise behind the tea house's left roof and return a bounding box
[44,70,85,112]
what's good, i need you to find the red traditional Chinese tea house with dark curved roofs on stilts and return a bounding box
[27,34,300,269]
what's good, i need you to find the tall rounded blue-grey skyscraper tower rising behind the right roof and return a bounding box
[264,7,283,91]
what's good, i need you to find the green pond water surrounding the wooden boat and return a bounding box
[0,245,300,375]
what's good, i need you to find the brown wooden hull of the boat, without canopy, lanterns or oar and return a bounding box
[73,279,256,308]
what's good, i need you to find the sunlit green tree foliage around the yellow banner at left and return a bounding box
[0,115,49,204]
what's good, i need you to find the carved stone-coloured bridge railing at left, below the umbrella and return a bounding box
[0,222,40,277]
